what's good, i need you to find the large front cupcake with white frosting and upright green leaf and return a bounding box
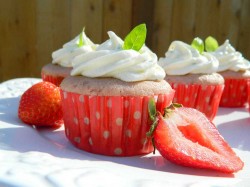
[60,24,174,156]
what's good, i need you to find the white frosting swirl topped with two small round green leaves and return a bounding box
[158,41,219,75]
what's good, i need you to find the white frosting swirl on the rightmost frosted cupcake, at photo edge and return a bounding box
[211,40,250,72]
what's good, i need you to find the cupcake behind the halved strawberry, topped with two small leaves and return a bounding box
[158,41,224,120]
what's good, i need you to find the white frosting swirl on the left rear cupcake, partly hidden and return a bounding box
[52,31,97,67]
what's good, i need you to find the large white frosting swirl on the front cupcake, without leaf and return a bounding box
[71,31,165,82]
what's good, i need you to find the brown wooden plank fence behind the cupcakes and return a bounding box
[0,0,250,82]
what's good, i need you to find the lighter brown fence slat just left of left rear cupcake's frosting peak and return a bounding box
[34,0,71,76]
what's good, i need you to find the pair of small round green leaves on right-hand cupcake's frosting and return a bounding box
[191,36,219,54]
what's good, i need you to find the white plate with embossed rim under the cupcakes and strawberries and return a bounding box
[0,78,250,187]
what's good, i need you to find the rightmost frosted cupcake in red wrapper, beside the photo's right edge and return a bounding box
[210,40,250,107]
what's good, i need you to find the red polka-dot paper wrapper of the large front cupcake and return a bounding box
[61,90,174,156]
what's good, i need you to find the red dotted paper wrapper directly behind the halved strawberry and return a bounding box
[170,83,224,120]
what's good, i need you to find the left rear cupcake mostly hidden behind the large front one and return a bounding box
[41,30,96,86]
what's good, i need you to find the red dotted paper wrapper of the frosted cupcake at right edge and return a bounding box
[220,79,248,107]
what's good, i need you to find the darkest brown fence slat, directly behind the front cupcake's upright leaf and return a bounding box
[132,0,154,48]
